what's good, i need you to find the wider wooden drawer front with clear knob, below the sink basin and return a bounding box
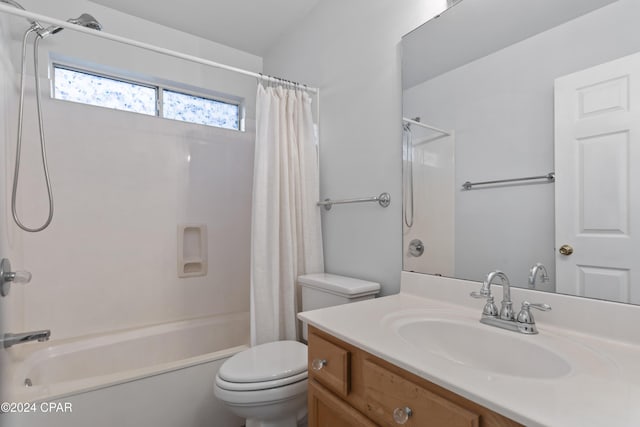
[363,360,480,427]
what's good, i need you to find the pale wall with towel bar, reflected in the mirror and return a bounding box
[404,0,640,290]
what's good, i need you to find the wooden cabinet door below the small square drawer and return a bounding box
[308,381,377,427]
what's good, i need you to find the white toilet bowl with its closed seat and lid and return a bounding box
[214,341,307,427]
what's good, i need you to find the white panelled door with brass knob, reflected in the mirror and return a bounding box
[555,54,640,304]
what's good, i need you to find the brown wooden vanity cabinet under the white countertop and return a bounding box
[309,326,520,427]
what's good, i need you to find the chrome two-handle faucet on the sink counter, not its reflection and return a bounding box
[471,270,551,334]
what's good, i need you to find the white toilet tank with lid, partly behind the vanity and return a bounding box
[298,273,380,341]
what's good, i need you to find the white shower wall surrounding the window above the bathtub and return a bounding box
[0,0,262,339]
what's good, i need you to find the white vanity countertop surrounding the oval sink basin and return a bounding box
[299,273,640,427]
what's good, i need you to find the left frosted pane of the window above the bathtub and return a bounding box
[54,67,157,116]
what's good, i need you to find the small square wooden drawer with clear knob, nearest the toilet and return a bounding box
[309,332,351,397]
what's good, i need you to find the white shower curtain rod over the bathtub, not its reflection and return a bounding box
[0,3,320,94]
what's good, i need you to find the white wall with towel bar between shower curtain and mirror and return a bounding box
[264,0,445,294]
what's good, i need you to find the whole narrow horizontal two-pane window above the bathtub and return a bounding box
[54,64,240,130]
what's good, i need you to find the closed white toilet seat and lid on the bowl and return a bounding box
[216,341,307,391]
